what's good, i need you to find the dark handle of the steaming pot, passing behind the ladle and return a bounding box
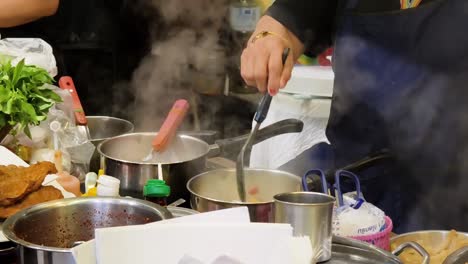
[208,119,304,161]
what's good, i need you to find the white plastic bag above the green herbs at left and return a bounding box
[0,38,57,77]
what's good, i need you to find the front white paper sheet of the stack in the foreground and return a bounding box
[96,223,293,264]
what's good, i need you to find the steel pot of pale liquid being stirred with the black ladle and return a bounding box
[187,168,301,222]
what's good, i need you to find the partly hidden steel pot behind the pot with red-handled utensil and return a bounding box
[86,116,134,172]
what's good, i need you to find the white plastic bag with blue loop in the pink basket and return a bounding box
[332,171,385,237]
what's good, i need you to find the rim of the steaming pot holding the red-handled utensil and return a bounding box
[96,132,210,165]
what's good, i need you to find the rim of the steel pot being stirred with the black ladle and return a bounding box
[187,168,300,206]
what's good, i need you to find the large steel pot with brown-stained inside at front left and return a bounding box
[3,197,172,264]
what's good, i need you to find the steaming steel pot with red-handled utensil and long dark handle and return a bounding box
[98,119,303,202]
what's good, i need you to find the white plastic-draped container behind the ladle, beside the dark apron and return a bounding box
[250,66,334,169]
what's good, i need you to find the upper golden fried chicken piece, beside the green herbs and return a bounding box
[0,161,57,206]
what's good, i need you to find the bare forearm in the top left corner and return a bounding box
[0,0,59,28]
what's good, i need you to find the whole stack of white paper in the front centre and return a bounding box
[72,207,312,264]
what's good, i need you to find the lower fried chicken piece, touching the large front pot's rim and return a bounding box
[0,186,63,218]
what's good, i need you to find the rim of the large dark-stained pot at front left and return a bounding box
[3,197,173,253]
